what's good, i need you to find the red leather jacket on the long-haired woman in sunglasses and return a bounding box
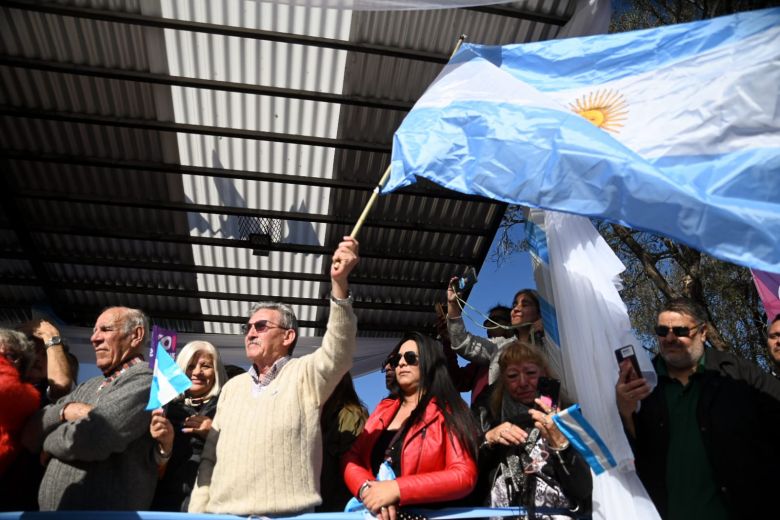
[341,399,477,506]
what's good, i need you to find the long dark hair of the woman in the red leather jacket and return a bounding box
[391,332,479,459]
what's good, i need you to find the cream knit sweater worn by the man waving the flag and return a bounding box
[189,303,357,515]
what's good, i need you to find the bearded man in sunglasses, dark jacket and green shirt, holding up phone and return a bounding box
[616,298,780,520]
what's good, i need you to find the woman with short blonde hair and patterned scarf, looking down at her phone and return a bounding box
[472,341,593,518]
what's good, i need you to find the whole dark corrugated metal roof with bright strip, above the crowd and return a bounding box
[0,0,574,374]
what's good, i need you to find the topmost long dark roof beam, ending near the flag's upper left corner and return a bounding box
[0,0,450,64]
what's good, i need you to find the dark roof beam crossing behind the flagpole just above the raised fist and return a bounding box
[16,190,488,237]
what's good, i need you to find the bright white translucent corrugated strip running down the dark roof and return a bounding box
[162,1,350,332]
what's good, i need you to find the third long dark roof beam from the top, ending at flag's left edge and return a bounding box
[0,105,391,154]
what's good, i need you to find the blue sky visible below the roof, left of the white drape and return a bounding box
[355,226,536,412]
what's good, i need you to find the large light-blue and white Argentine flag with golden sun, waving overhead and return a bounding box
[383,9,780,272]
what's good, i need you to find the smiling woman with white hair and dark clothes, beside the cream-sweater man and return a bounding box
[149,341,227,511]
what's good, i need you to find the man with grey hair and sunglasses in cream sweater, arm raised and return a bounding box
[189,237,358,516]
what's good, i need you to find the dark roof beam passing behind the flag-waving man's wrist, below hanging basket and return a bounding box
[0,251,447,290]
